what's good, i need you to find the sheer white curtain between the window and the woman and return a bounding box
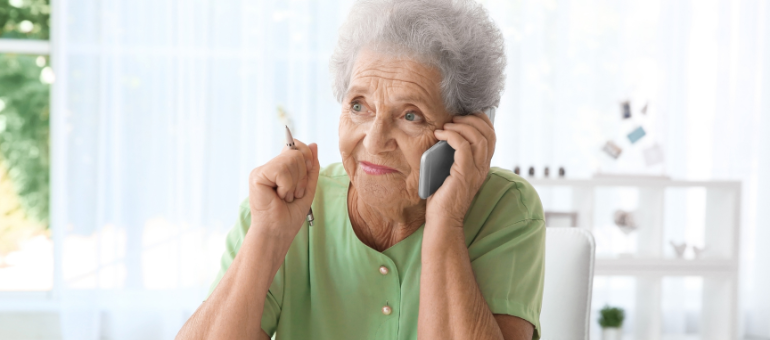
[52,0,356,339]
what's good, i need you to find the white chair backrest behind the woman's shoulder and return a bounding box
[540,228,596,340]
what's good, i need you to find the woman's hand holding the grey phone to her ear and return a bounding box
[425,113,496,227]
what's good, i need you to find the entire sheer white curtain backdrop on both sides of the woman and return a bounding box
[51,0,770,339]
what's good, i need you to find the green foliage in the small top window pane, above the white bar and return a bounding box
[0,0,51,40]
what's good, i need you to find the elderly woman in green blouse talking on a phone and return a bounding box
[178,0,545,339]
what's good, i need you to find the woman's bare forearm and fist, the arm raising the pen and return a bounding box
[177,139,321,339]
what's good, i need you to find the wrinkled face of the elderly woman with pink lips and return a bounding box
[339,50,452,208]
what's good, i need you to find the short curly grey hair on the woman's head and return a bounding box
[329,0,506,115]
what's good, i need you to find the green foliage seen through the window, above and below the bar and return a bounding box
[0,0,53,240]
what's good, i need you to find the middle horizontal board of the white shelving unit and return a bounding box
[594,258,738,276]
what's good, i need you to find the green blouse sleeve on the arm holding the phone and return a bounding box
[468,182,545,339]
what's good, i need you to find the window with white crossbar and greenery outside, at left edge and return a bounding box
[0,0,54,291]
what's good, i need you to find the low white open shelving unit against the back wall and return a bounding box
[528,177,741,340]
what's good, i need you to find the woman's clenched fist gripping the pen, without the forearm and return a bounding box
[249,139,321,246]
